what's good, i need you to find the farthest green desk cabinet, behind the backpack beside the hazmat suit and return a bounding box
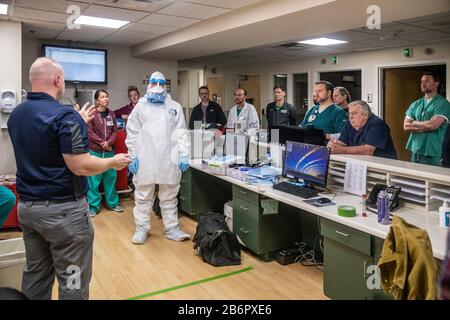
[178,168,231,216]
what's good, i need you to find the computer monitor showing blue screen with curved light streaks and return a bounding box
[283,141,330,188]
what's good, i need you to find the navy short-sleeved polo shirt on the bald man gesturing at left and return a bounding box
[8,92,88,201]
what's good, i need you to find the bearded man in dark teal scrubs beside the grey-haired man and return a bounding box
[300,81,348,140]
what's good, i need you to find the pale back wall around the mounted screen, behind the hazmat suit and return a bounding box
[22,38,178,110]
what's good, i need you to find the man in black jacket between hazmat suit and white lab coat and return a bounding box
[189,86,227,130]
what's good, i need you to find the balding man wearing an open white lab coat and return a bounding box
[227,89,259,131]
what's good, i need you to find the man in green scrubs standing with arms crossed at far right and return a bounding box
[403,72,450,166]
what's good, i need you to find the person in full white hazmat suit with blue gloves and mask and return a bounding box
[125,72,190,244]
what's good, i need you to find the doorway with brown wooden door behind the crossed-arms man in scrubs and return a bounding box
[381,64,446,161]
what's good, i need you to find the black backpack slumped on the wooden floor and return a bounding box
[192,212,241,267]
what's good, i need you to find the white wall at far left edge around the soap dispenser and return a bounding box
[0,21,22,174]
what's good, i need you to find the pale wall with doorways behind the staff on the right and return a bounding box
[205,42,450,115]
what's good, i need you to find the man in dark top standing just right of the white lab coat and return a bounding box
[266,86,297,129]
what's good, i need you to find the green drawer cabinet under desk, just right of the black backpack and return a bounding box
[233,185,301,261]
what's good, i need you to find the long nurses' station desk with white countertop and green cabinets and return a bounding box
[179,155,450,299]
